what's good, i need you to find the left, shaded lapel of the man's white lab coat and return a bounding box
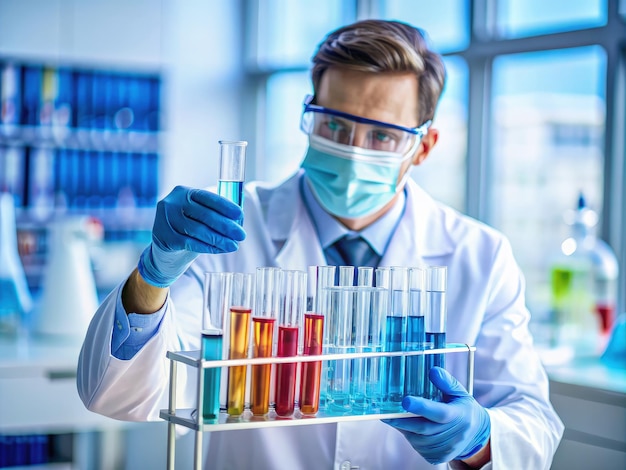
[268,170,326,269]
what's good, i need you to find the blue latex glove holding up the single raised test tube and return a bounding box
[138,186,246,287]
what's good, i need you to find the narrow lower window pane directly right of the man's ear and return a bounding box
[412,57,469,211]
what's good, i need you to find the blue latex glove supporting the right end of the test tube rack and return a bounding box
[385,367,491,465]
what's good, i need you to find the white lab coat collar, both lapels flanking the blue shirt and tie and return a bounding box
[267,170,455,268]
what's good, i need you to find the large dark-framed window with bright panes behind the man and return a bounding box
[247,0,626,317]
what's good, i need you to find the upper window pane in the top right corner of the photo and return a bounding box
[496,0,607,37]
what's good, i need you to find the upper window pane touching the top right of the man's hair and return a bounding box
[383,0,470,52]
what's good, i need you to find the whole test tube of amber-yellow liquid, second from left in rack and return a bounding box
[227,273,253,417]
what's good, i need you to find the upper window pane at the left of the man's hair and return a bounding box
[249,0,355,67]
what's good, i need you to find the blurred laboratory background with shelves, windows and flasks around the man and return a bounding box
[0,0,626,469]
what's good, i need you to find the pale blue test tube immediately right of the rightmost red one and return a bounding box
[326,287,357,414]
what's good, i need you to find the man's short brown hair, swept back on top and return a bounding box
[311,20,445,123]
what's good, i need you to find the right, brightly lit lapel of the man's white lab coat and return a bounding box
[380,179,454,266]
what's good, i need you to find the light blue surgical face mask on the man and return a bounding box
[301,135,420,219]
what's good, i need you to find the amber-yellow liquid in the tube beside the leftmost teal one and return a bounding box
[227,307,252,416]
